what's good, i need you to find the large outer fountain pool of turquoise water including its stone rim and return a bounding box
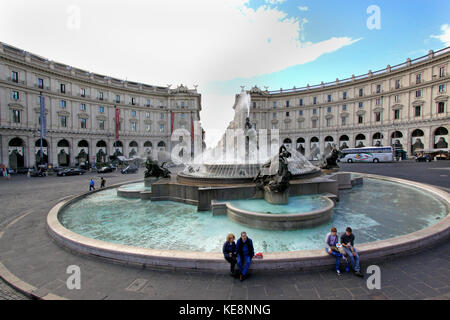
[47,175,450,270]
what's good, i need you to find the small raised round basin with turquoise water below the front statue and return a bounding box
[226,195,334,230]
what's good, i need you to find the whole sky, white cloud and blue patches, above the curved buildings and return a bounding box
[0,0,450,146]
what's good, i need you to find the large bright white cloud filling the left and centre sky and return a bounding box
[0,0,359,147]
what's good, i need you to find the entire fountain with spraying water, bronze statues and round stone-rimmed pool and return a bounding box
[47,90,450,270]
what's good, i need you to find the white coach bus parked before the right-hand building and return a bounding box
[340,147,394,163]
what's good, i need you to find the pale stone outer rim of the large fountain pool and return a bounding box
[47,173,450,271]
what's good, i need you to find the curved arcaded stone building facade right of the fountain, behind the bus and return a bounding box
[249,47,450,160]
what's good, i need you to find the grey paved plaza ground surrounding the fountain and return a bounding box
[0,161,450,300]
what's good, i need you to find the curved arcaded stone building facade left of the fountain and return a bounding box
[0,43,201,168]
